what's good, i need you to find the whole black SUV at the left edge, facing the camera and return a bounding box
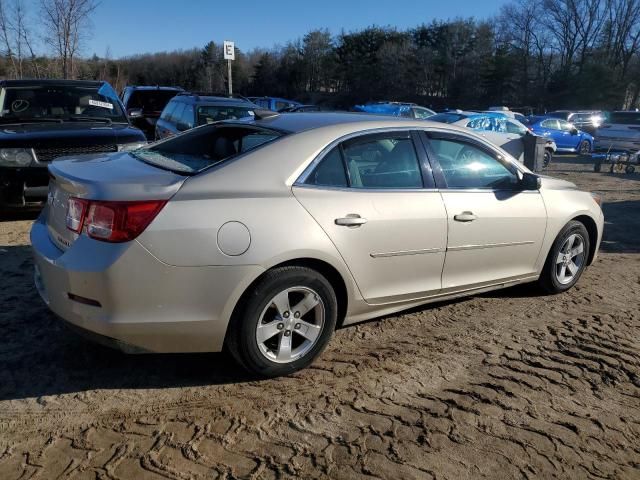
[0,80,146,210]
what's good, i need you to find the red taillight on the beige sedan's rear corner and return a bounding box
[67,197,167,242]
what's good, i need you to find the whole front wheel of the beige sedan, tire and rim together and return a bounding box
[538,220,590,294]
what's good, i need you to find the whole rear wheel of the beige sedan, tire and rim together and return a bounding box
[226,266,338,377]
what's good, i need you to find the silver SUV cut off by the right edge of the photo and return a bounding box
[594,112,640,152]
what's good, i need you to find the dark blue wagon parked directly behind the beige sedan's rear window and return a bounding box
[155,92,258,140]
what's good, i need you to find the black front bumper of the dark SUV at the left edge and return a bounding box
[0,167,49,208]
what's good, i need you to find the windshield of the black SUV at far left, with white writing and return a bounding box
[0,84,128,123]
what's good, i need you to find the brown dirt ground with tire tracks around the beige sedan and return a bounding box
[0,157,640,480]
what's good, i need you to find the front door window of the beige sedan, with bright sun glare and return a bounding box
[429,138,518,189]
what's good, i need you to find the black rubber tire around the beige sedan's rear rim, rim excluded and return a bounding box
[225,266,338,377]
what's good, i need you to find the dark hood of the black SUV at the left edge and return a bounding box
[0,122,145,148]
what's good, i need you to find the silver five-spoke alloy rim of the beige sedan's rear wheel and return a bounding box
[256,287,325,363]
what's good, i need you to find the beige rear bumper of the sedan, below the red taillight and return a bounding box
[31,215,262,352]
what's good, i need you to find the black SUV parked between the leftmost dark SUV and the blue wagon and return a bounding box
[121,86,183,140]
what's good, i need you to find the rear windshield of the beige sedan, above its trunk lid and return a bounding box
[131,124,283,175]
